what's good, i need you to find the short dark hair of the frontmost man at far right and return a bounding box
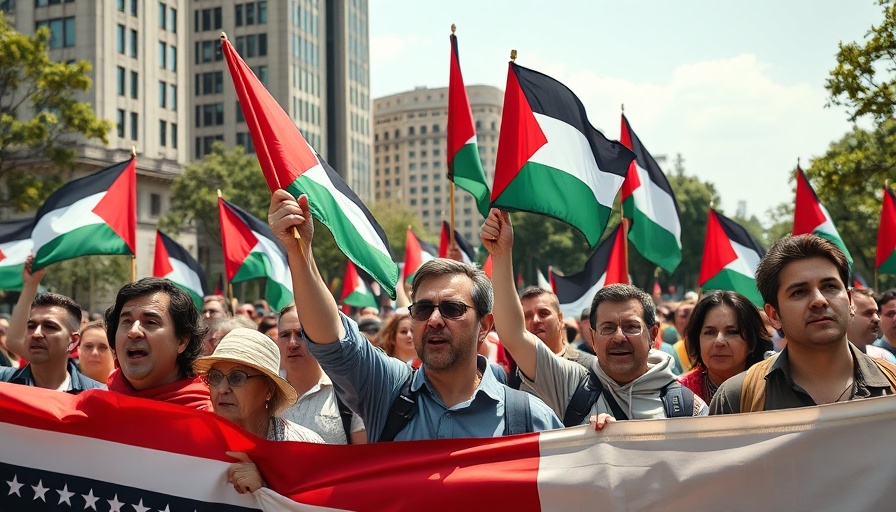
[756,235,849,309]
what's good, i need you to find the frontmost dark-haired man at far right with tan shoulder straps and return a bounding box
[710,235,896,414]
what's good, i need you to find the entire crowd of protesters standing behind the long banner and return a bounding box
[0,191,896,492]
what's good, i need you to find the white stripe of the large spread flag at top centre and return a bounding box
[529,113,625,208]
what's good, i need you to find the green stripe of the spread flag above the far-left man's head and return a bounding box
[34,224,131,270]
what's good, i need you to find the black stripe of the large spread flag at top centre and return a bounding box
[510,63,635,178]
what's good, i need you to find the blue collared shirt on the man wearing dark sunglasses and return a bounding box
[302,313,563,442]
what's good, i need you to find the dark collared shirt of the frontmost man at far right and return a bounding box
[709,343,892,414]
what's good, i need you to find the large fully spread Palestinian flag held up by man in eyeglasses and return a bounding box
[492,62,635,246]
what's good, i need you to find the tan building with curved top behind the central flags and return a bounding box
[373,85,496,247]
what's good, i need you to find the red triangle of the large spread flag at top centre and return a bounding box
[492,63,548,201]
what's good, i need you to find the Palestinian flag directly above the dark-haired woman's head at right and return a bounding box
[699,210,765,307]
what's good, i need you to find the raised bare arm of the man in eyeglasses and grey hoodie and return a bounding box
[480,208,538,380]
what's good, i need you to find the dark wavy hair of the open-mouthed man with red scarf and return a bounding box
[106,277,208,377]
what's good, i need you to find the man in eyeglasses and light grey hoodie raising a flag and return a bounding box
[481,209,707,427]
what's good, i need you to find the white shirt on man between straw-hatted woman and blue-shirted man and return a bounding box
[281,373,364,444]
